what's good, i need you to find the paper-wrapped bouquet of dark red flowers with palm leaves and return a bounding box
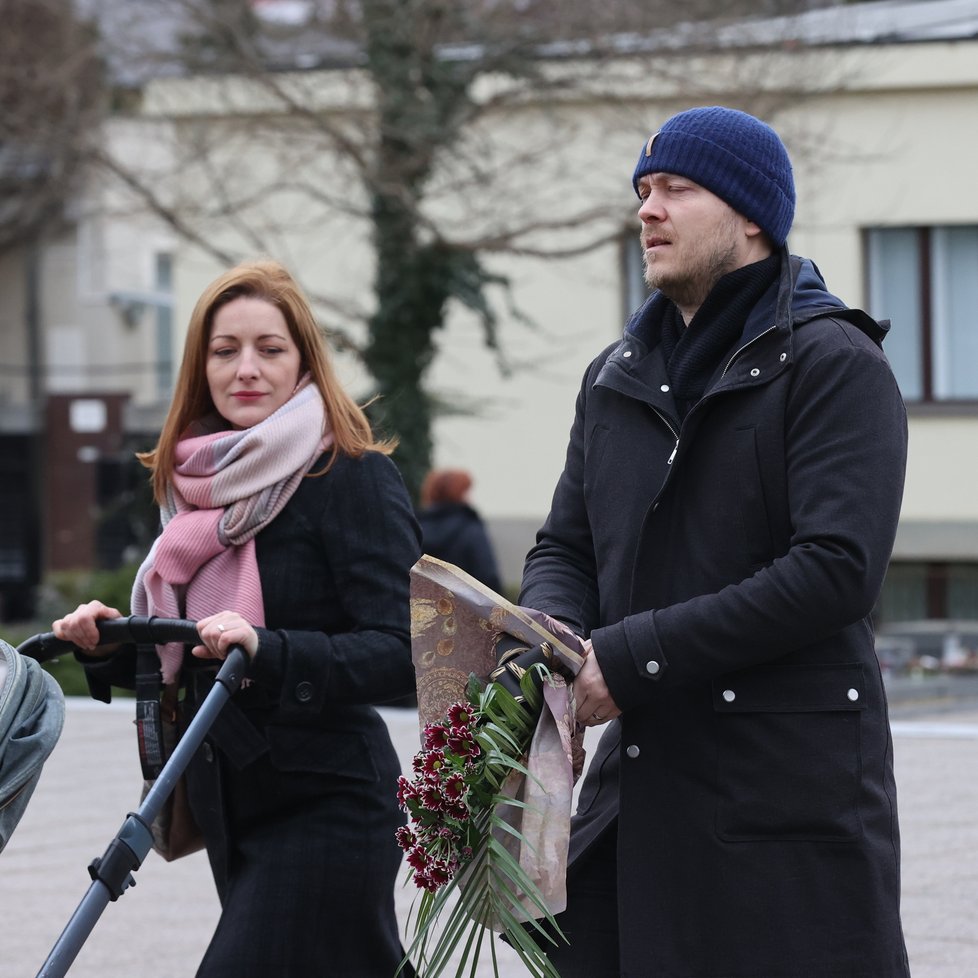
[398,556,586,978]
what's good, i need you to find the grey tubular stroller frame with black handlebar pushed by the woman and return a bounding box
[12,615,248,978]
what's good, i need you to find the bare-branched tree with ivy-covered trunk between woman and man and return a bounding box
[89,0,840,492]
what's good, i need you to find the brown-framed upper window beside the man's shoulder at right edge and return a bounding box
[866,225,978,401]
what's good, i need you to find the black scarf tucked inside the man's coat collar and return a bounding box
[661,253,781,418]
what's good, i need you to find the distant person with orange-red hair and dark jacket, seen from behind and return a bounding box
[418,469,502,593]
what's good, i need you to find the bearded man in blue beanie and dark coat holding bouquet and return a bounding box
[520,106,909,978]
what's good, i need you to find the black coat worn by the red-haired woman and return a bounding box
[88,452,420,978]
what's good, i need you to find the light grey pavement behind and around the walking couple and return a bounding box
[0,699,978,978]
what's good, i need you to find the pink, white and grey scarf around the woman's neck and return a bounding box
[132,379,333,683]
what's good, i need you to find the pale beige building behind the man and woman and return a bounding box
[0,0,978,620]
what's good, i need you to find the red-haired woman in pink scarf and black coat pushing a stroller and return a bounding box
[53,261,420,978]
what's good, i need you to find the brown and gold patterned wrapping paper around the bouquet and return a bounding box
[411,555,585,930]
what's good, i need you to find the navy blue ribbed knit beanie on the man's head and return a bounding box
[632,105,795,246]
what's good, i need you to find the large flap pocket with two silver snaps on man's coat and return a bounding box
[713,663,864,842]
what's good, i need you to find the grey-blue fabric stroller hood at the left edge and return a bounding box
[0,640,65,851]
